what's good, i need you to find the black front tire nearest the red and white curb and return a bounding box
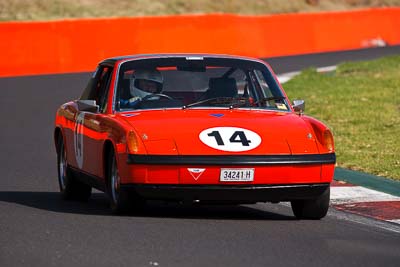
[291,187,330,220]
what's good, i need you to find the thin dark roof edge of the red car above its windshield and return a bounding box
[100,53,265,64]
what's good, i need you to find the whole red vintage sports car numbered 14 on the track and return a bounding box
[54,54,336,219]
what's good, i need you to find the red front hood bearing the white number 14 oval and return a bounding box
[121,109,318,155]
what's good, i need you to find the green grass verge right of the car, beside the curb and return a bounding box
[284,56,400,180]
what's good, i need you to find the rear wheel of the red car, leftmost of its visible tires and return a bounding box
[57,137,92,201]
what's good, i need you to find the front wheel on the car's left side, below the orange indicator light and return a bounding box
[107,150,145,214]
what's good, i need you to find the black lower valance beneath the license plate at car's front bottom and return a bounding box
[121,183,330,203]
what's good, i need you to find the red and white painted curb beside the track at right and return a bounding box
[331,181,400,224]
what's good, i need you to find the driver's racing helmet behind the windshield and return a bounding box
[129,69,163,98]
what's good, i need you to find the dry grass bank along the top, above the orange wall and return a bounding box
[0,0,400,21]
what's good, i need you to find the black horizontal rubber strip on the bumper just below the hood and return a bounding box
[127,153,336,165]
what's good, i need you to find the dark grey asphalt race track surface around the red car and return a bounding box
[0,47,400,266]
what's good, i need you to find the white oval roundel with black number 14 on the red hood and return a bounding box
[199,127,261,152]
